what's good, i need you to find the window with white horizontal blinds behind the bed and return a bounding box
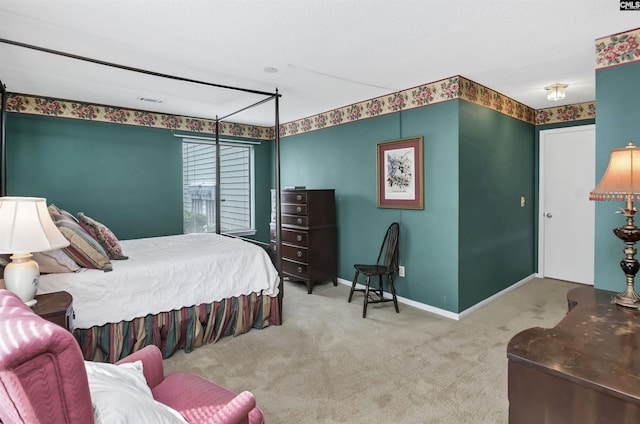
[182,139,255,235]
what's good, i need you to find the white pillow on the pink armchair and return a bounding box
[84,361,186,424]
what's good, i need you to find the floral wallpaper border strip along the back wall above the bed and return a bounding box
[7,93,275,140]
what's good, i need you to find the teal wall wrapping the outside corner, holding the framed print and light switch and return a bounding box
[281,100,536,313]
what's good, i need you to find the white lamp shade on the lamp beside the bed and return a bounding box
[0,196,69,253]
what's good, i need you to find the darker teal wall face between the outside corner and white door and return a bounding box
[459,101,537,310]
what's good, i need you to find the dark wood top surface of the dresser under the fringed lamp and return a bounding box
[507,287,640,404]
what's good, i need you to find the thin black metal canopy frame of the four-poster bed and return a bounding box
[0,38,284,322]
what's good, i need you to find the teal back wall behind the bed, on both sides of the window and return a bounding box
[6,113,272,240]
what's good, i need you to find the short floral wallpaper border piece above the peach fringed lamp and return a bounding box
[596,28,640,70]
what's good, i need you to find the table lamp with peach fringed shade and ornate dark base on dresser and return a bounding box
[589,142,640,308]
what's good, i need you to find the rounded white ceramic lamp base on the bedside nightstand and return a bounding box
[4,253,40,306]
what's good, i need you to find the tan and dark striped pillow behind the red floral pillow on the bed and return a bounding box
[49,205,113,271]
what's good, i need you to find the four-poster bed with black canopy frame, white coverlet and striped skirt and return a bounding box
[0,39,283,362]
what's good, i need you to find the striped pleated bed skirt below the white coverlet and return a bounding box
[73,293,280,363]
